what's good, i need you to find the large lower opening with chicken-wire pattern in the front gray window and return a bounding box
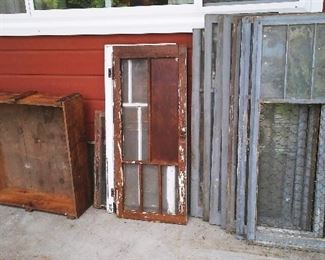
[257,104,319,231]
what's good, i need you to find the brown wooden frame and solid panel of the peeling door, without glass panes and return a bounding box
[113,44,187,224]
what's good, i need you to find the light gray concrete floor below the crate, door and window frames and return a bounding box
[0,206,325,260]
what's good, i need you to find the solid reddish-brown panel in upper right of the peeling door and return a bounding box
[150,58,179,163]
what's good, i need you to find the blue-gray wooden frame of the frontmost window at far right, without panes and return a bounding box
[240,14,325,249]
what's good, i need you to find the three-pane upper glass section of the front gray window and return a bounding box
[261,24,325,100]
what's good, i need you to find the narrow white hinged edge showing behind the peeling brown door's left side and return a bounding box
[104,45,115,213]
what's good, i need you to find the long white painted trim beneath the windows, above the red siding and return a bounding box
[0,0,323,36]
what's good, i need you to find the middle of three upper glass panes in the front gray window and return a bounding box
[287,25,314,98]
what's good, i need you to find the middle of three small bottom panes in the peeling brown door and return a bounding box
[143,165,159,212]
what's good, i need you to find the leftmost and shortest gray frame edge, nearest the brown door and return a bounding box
[191,29,203,217]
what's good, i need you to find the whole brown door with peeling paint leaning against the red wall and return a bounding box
[113,44,187,224]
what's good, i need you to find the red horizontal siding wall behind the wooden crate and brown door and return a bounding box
[0,34,192,140]
